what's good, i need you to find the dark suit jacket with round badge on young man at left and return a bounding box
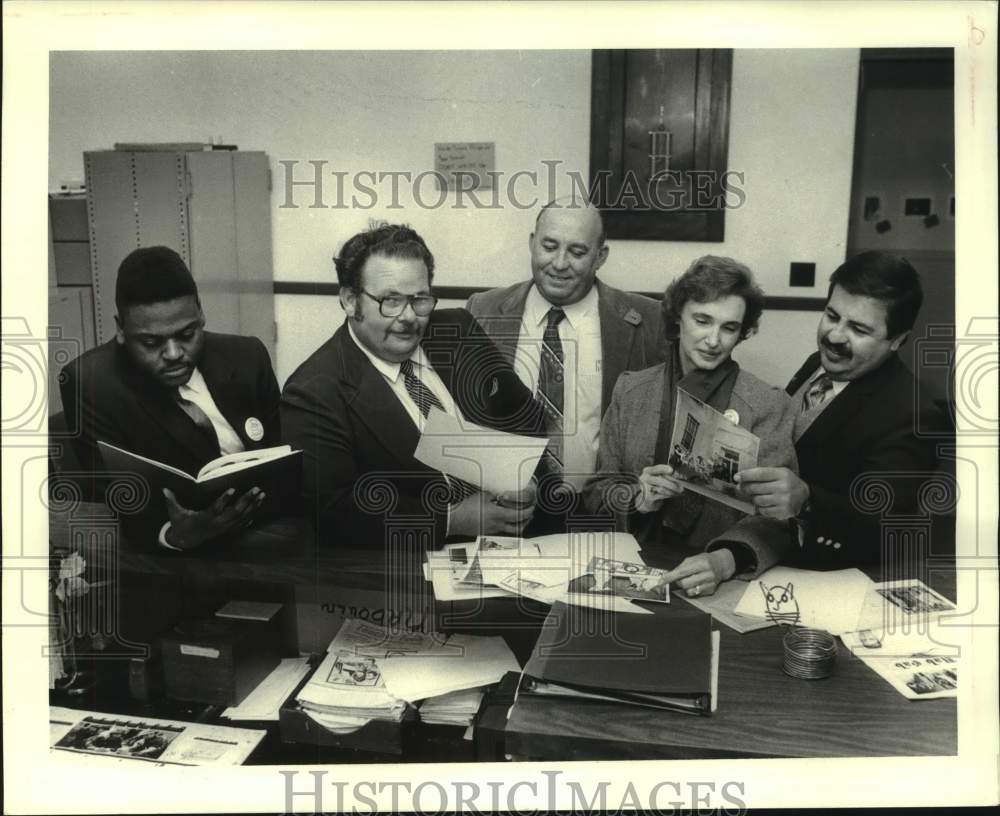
[60,332,281,540]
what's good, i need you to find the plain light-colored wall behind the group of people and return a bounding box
[49,49,858,382]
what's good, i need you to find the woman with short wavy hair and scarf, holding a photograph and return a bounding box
[584,255,796,597]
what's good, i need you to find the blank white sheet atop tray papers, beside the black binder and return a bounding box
[380,635,521,702]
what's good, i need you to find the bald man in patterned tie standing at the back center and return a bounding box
[467,197,663,535]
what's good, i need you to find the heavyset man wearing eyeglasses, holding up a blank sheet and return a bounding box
[281,224,544,548]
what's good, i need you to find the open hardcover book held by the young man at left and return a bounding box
[97,441,302,510]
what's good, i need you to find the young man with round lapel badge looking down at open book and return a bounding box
[61,246,280,550]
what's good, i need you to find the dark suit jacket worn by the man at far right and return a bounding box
[786,353,943,568]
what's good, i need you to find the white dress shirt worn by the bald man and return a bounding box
[514,286,603,491]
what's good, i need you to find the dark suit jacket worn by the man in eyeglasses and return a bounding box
[281,309,544,549]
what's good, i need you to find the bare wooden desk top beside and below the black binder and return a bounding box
[507,592,957,760]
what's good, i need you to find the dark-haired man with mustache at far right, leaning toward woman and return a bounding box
[736,251,942,567]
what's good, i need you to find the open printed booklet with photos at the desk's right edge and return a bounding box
[841,580,961,700]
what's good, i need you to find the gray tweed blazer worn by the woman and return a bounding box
[583,365,797,579]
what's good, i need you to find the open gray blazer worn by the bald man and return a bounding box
[465,281,664,414]
